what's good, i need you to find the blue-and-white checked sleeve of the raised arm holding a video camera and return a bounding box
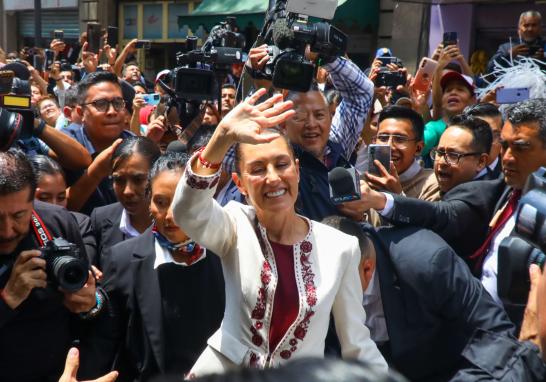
[324,57,374,158]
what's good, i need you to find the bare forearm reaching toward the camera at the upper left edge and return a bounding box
[41,119,91,170]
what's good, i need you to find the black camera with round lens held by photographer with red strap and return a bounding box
[41,238,89,292]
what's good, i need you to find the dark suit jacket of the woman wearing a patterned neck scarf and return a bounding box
[96,229,225,381]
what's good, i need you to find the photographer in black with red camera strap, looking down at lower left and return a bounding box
[0,150,104,382]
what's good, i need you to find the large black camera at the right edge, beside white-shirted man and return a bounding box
[497,167,546,305]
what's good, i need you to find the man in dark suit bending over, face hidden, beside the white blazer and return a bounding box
[323,216,546,381]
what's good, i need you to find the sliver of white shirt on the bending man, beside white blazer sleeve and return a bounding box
[362,271,389,343]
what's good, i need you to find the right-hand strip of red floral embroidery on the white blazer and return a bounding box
[280,240,317,359]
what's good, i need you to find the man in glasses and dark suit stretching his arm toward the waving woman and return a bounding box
[346,116,504,259]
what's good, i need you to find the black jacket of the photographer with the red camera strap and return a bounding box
[0,201,92,382]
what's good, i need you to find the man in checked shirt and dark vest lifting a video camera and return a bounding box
[247,45,374,220]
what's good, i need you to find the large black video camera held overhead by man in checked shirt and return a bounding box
[254,0,347,92]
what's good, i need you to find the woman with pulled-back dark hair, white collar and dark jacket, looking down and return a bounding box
[91,137,160,268]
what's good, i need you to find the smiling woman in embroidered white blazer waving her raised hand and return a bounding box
[172,90,387,377]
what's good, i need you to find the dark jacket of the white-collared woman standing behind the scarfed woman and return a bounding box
[91,202,128,269]
